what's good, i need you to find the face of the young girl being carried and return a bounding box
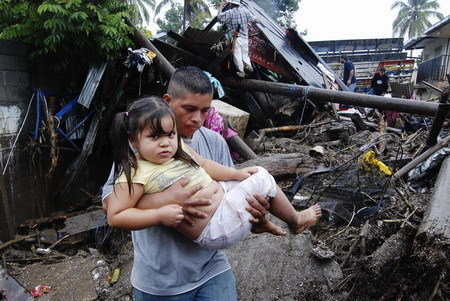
[131,115,178,164]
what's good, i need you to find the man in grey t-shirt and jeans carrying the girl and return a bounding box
[102,66,269,301]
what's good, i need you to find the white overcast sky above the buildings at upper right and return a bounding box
[295,0,450,42]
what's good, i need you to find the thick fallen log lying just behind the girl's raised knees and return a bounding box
[236,153,316,179]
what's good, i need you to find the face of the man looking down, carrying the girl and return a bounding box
[163,93,212,138]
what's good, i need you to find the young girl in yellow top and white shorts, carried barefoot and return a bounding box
[107,97,321,249]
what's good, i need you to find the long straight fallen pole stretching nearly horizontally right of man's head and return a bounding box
[220,77,442,117]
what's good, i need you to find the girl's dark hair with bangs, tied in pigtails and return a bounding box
[111,96,198,193]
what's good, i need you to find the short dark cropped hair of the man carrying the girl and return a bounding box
[167,66,214,98]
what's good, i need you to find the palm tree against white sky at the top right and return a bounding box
[391,0,444,39]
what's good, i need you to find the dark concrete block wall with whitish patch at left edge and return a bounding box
[0,40,45,241]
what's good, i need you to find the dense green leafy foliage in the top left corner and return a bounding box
[0,0,132,68]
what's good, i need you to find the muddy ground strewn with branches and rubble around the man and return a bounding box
[0,112,450,300]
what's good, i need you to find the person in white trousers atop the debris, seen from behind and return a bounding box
[217,0,257,78]
